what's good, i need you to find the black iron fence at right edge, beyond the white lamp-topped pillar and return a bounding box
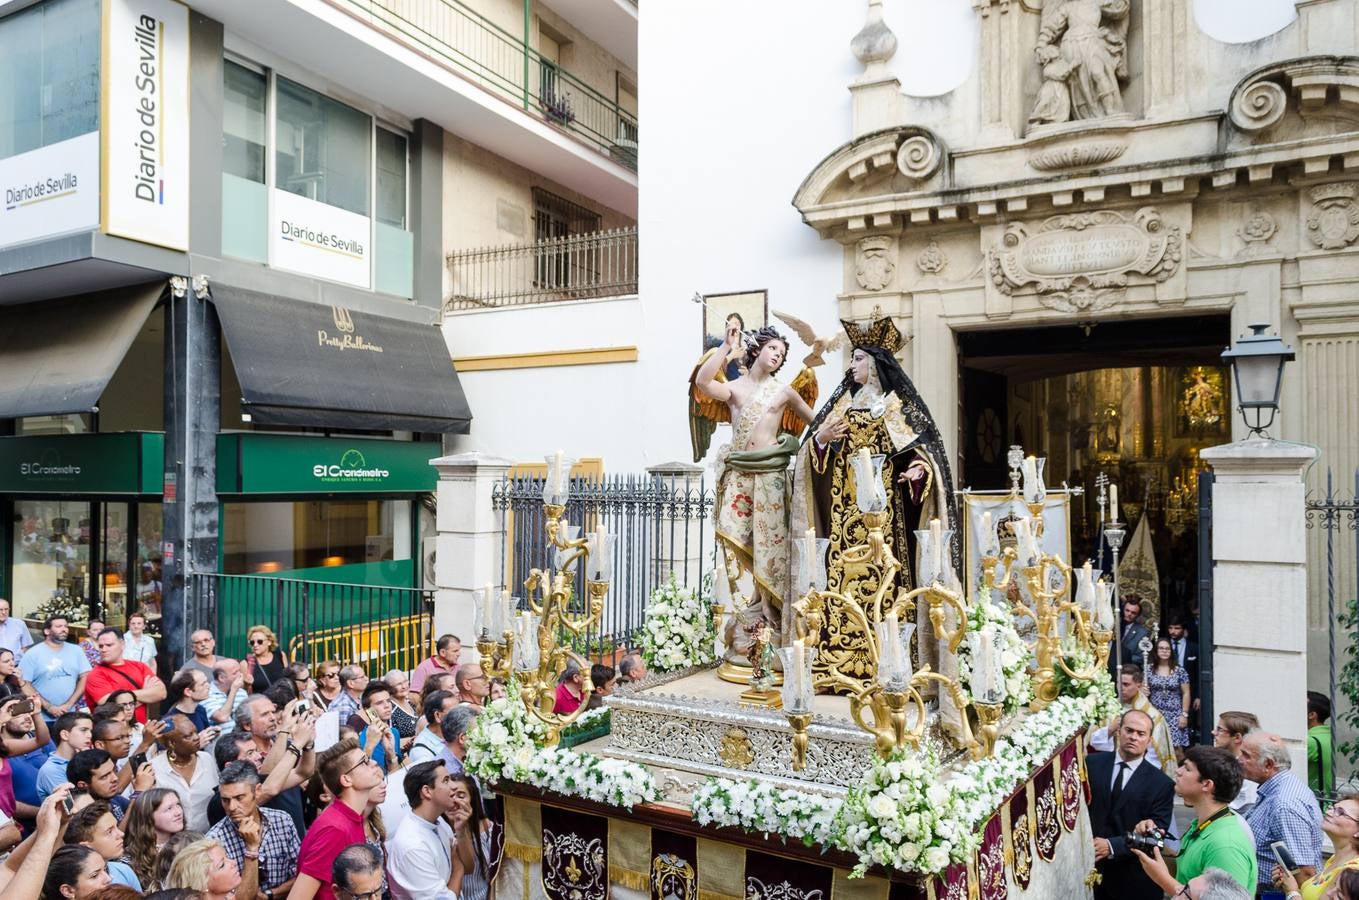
[1306,469,1359,784]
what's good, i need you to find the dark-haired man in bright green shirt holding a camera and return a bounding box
[1132,746,1258,896]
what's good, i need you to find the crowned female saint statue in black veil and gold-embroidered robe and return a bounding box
[786,317,958,685]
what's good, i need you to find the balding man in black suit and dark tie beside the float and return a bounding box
[1086,710,1176,900]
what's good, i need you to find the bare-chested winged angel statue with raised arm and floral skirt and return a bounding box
[689,319,817,666]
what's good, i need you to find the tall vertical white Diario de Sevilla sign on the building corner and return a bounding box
[102,0,189,250]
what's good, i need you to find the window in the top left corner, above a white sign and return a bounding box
[0,0,101,159]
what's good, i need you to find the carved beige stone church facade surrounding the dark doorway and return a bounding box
[794,0,1359,704]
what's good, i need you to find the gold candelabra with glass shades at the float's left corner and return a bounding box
[477,453,614,746]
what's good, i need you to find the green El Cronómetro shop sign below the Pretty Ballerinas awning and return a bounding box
[217,434,442,496]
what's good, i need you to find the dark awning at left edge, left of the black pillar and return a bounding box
[0,280,166,419]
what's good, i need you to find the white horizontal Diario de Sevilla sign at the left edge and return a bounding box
[0,132,99,247]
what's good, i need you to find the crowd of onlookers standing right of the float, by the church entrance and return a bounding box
[1087,600,1342,900]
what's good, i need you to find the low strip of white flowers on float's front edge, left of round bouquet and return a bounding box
[692,778,843,847]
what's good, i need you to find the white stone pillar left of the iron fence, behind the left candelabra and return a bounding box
[429,451,510,662]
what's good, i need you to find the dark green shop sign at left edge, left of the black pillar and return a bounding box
[0,431,166,496]
